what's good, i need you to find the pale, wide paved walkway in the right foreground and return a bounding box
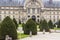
[20,32,60,40]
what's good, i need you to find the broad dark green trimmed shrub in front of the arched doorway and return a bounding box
[24,19,37,35]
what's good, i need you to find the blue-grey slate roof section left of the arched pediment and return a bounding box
[0,0,23,6]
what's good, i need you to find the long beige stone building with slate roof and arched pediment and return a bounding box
[0,0,60,23]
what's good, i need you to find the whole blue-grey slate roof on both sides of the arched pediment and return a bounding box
[0,0,60,7]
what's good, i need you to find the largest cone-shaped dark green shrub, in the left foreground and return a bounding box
[0,16,17,40]
